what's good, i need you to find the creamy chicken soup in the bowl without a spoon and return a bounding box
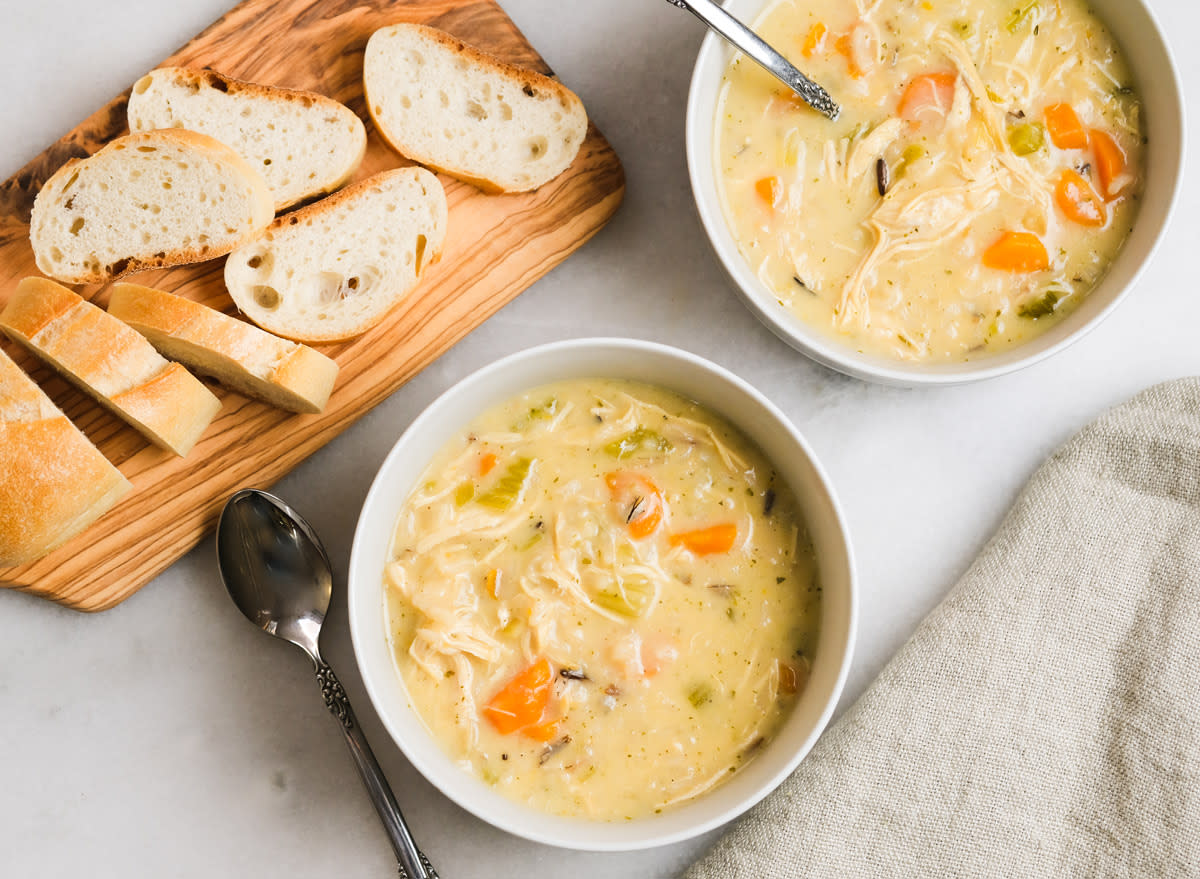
[384,381,820,820]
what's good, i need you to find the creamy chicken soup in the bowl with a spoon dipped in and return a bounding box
[716,0,1144,361]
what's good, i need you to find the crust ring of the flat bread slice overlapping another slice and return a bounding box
[30,128,275,283]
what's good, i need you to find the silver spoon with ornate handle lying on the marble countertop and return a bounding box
[217,489,438,879]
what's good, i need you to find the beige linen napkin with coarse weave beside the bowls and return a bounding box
[688,379,1200,879]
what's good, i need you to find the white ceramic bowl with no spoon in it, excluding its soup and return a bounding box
[348,339,856,850]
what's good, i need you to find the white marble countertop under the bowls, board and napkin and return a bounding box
[0,0,1200,879]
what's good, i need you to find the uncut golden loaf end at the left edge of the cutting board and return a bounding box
[0,351,131,568]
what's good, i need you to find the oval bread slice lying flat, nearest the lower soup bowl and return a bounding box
[226,167,446,342]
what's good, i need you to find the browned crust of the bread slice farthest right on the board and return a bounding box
[362,23,583,195]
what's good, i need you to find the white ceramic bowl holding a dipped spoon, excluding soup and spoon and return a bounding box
[686,0,1184,385]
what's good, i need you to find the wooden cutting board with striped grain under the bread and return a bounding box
[0,0,624,611]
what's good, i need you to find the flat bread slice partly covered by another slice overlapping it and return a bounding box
[128,67,367,211]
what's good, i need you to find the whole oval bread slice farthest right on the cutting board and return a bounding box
[362,24,588,192]
